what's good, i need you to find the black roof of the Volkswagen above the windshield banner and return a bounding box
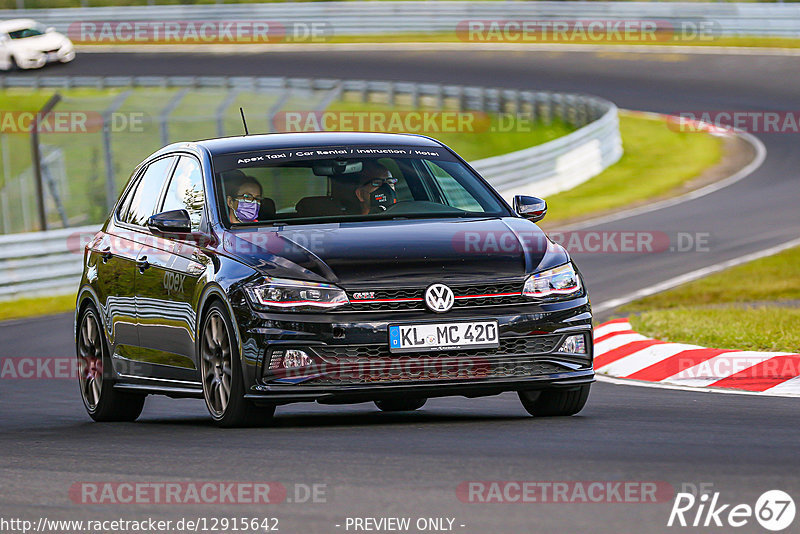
[194,132,443,155]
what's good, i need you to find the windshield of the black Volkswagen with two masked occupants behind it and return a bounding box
[214,147,509,225]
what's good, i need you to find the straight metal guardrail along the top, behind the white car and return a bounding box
[0,1,800,36]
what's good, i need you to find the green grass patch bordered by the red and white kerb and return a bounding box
[618,247,800,352]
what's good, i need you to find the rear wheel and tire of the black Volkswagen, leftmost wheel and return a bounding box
[75,305,145,422]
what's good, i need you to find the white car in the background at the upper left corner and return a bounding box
[0,19,75,70]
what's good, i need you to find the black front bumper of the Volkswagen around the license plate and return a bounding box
[235,296,594,404]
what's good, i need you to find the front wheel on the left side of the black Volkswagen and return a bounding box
[198,302,275,428]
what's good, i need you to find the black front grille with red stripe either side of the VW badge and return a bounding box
[336,280,530,312]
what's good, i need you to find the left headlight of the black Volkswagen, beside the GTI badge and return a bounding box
[241,278,350,311]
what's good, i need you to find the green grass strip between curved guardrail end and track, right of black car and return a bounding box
[545,114,722,227]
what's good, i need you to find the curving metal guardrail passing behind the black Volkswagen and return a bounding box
[0,76,622,300]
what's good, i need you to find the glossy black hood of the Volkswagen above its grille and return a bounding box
[223,217,569,288]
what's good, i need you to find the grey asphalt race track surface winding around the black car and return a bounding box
[0,51,800,533]
